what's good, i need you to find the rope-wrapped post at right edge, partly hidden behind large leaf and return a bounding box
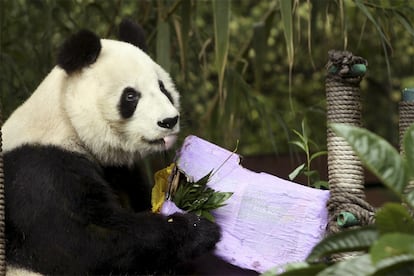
[398,88,414,211]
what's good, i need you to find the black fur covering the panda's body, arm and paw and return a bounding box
[4,145,220,275]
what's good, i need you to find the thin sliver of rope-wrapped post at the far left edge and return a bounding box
[0,104,6,276]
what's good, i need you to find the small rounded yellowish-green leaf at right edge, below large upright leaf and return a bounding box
[375,203,414,234]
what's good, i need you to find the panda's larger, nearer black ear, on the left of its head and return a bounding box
[57,30,102,74]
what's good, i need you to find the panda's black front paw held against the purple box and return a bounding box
[168,213,221,260]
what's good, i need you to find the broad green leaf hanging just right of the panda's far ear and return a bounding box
[157,18,171,72]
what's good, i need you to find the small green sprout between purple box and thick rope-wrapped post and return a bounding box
[289,120,328,188]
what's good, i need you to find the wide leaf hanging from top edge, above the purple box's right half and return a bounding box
[279,0,294,66]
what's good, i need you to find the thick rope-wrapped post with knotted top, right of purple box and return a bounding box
[326,50,374,237]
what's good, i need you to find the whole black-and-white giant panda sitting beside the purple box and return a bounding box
[2,20,220,275]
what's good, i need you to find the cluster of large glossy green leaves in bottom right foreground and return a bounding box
[264,124,414,275]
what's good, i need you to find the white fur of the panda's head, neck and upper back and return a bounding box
[3,39,179,165]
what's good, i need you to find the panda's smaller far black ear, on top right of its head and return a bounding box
[118,19,147,51]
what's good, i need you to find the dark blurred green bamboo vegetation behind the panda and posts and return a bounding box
[0,0,414,155]
